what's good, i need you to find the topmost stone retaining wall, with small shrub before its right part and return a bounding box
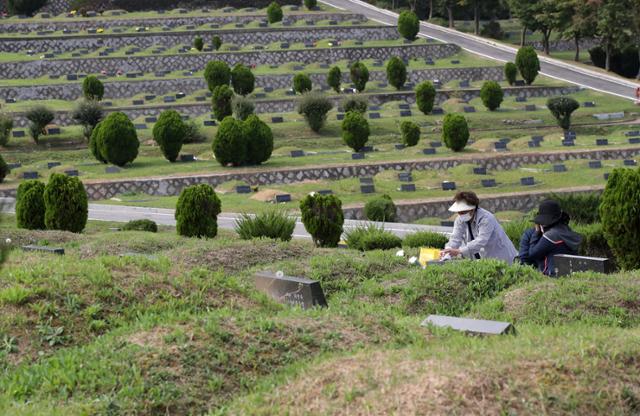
[0,11,366,33]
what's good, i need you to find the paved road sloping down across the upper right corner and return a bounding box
[320,0,640,100]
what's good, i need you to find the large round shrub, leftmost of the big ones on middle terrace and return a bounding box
[90,112,140,166]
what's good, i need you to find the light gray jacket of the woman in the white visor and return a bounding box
[446,208,518,264]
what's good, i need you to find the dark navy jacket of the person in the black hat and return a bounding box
[520,223,582,276]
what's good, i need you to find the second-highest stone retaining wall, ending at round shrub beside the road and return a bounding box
[0,26,398,54]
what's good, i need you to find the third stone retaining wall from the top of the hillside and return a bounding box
[0,44,460,79]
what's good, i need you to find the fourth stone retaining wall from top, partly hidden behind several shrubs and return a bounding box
[0,67,504,101]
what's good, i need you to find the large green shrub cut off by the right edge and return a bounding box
[600,168,640,270]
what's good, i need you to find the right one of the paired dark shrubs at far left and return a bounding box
[44,173,89,233]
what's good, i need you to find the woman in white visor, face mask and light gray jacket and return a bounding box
[441,192,518,264]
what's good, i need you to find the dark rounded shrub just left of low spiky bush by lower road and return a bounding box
[175,184,221,238]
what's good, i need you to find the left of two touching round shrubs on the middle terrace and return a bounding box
[211,117,247,166]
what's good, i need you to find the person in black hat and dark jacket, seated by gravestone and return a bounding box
[519,199,582,276]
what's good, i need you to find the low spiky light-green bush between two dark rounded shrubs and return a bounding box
[235,209,296,241]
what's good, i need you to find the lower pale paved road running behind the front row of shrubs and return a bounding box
[0,198,451,238]
